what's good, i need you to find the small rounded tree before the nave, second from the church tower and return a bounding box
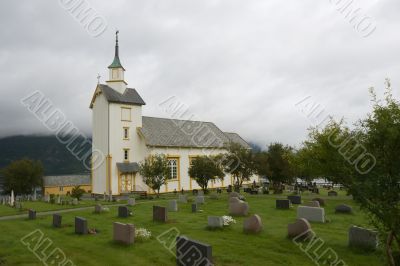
[188,156,225,193]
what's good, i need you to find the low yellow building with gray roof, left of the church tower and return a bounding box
[43,175,92,195]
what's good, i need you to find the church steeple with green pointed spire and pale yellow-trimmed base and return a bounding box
[107,30,127,94]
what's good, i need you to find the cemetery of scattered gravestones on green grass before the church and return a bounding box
[0,190,383,265]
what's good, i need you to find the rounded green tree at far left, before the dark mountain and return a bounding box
[2,159,43,194]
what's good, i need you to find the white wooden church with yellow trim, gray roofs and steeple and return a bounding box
[90,32,258,195]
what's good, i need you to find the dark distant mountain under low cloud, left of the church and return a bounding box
[0,136,89,175]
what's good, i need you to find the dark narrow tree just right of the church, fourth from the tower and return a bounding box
[267,143,294,193]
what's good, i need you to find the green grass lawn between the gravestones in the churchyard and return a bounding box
[0,191,383,266]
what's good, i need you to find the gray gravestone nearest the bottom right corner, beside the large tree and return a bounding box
[349,226,378,250]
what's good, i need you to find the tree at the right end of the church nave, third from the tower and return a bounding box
[220,142,256,189]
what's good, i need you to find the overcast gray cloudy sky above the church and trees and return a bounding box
[0,0,400,146]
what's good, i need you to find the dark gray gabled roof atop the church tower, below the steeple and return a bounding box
[91,84,146,107]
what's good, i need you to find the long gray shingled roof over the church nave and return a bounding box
[138,116,250,148]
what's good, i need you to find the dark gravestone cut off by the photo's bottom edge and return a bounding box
[176,236,214,266]
